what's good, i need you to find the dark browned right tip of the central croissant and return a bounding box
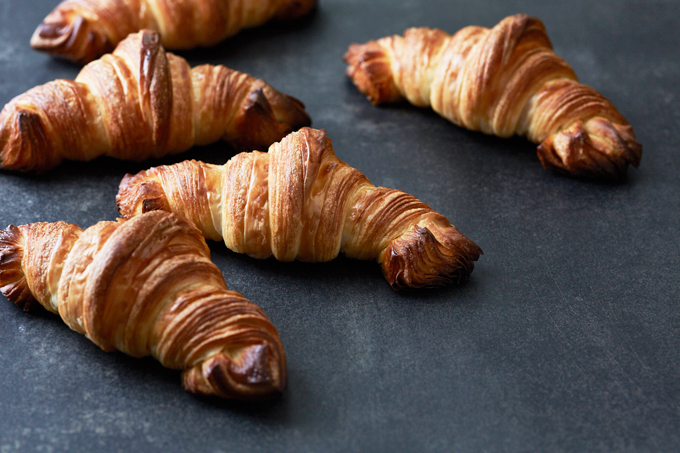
[380,219,482,290]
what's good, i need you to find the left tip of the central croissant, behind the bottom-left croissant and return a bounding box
[116,170,170,219]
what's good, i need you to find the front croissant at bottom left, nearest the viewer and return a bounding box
[0,212,286,399]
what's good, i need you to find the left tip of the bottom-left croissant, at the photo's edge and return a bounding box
[0,225,35,311]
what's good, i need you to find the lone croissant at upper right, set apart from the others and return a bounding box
[344,14,642,179]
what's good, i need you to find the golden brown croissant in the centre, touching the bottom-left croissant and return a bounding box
[116,128,482,289]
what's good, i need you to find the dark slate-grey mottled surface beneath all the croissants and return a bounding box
[0,0,680,452]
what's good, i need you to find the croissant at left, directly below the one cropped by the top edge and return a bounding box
[0,30,310,171]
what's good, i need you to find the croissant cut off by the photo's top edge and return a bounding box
[31,0,316,63]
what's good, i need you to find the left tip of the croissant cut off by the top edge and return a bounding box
[31,10,114,64]
